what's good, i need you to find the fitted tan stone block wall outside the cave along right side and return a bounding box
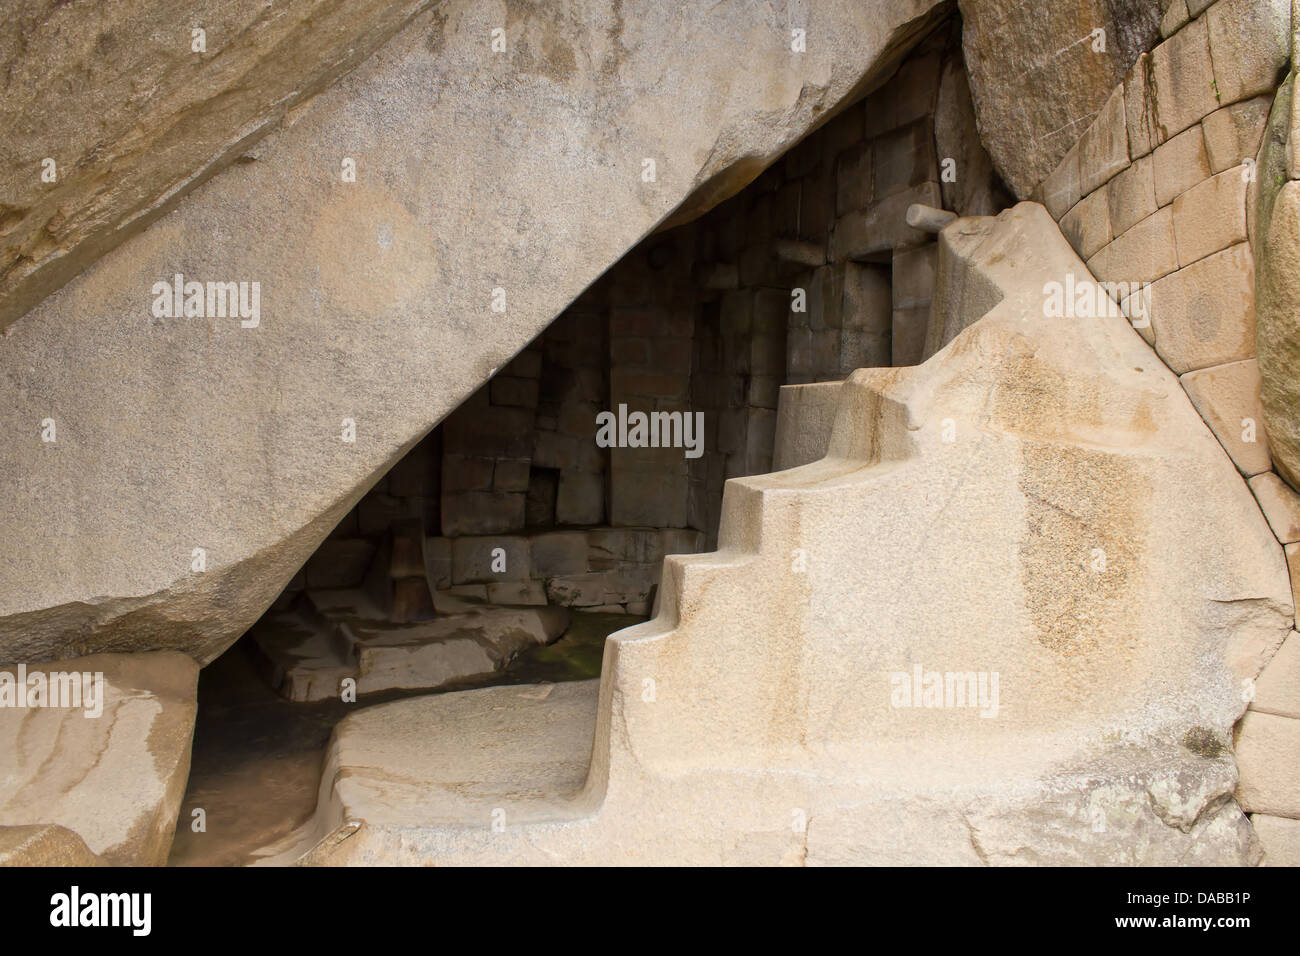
[1035,0,1300,865]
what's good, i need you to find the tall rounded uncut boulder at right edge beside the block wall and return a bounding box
[1252,77,1300,489]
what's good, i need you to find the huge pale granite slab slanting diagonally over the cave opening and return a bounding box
[0,0,936,662]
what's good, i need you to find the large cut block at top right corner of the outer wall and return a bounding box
[1205,0,1291,103]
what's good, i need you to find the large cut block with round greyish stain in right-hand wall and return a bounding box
[1154,239,1255,375]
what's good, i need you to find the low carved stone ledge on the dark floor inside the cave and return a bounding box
[252,588,569,701]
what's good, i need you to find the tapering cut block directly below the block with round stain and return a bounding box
[1180,356,1273,477]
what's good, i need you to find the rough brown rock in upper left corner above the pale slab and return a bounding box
[0,0,432,329]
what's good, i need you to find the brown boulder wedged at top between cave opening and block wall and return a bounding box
[958,0,1162,199]
